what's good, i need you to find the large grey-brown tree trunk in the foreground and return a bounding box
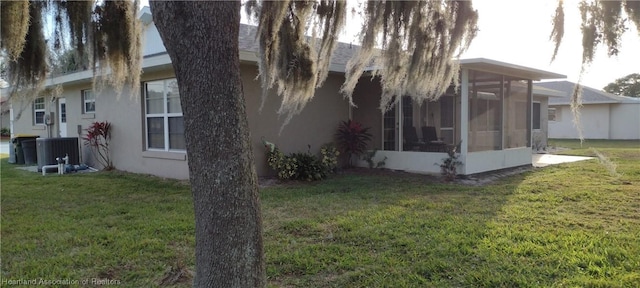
[151,1,265,287]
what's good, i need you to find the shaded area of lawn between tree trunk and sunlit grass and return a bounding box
[262,171,526,287]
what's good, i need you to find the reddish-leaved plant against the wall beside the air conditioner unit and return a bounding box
[82,121,114,170]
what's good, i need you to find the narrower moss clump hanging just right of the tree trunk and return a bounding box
[250,0,346,123]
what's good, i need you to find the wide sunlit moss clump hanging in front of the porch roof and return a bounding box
[342,1,478,111]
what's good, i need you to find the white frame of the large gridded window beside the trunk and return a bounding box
[143,78,186,152]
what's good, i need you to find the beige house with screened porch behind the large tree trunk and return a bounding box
[14,7,564,179]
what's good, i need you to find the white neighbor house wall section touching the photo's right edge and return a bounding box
[609,103,640,140]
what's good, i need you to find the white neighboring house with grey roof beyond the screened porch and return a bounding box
[536,81,640,140]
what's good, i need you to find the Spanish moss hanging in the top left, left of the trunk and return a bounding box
[1,0,142,102]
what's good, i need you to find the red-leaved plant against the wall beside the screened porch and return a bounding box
[336,119,372,166]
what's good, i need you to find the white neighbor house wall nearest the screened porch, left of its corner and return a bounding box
[549,104,611,139]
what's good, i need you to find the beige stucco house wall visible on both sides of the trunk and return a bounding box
[14,64,349,179]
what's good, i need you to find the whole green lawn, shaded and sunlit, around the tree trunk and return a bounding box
[0,142,640,287]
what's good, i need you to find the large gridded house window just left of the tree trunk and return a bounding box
[144,79,186,151]
